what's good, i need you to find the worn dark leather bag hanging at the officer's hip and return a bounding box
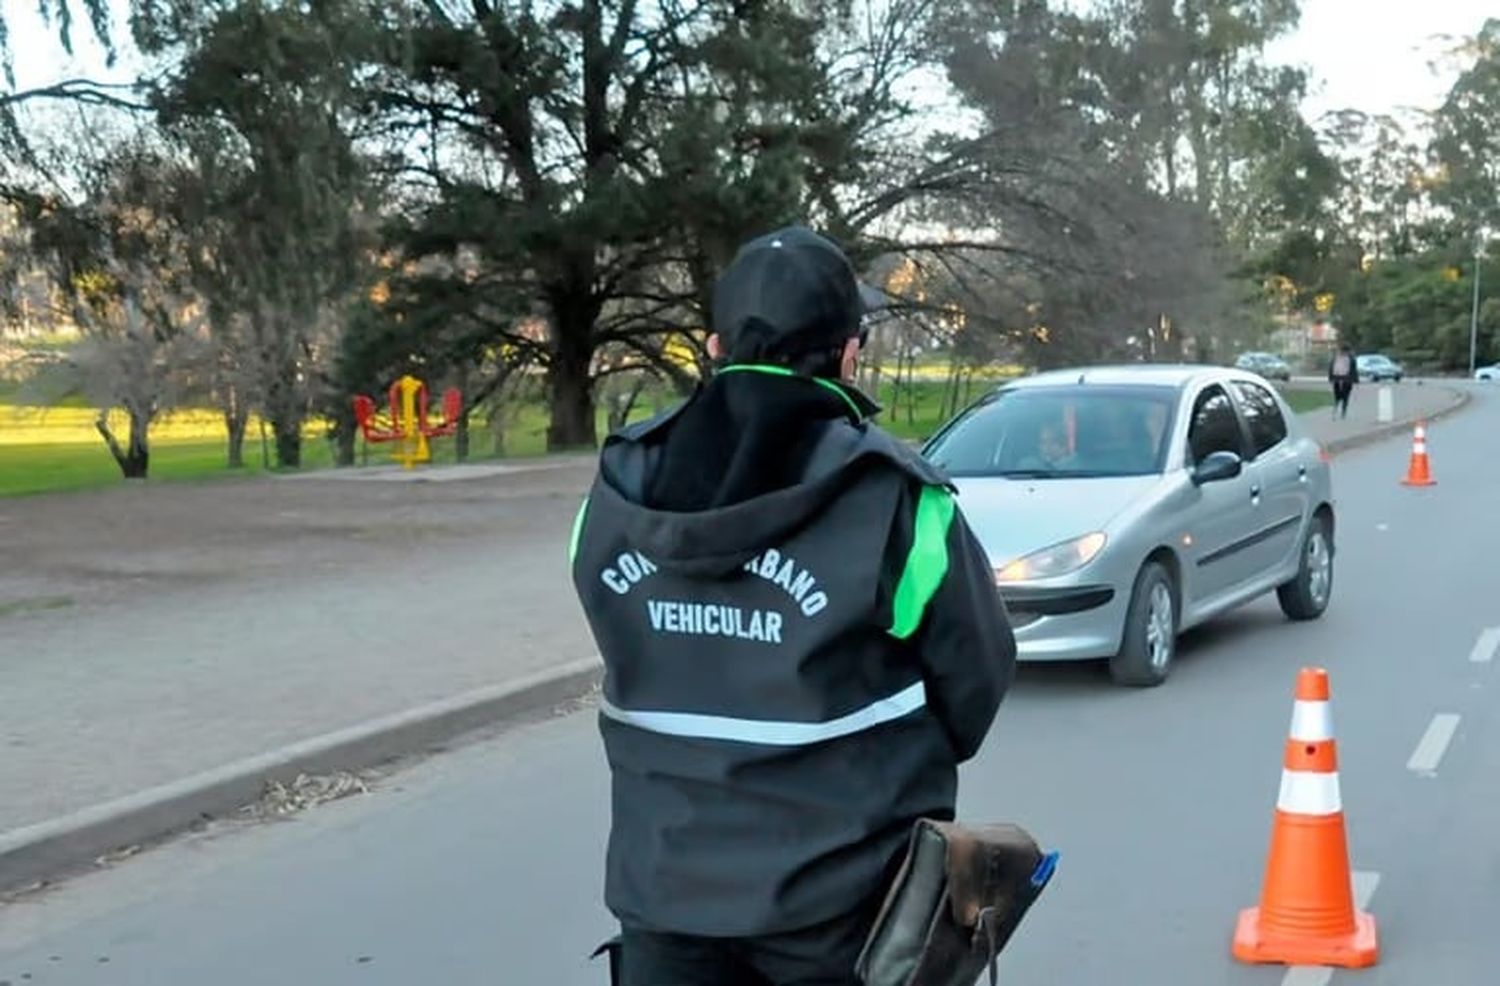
[855,819,1058,986]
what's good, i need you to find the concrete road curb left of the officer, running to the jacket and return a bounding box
[0,657,603,891]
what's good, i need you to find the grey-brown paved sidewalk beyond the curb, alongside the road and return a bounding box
[0,381,1455,864]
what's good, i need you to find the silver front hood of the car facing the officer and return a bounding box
[953,476,1167,567]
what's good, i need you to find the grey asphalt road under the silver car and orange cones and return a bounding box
[0,392,1500,986]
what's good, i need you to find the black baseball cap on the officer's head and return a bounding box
[713,227,866,362]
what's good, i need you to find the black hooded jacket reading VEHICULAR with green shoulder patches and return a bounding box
[573,368,1016,936]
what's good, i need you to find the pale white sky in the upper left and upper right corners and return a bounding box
[0,0,1500,122]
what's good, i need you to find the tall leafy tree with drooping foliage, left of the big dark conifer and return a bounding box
[137,0,374,467]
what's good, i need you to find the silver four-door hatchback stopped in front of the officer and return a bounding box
[924,366,1334,684]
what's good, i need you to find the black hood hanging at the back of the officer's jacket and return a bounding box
[591,366,948,576]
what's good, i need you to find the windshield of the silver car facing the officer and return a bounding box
[924,384,1178,479]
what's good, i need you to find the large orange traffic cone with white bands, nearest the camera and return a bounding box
[1233,668,1380,968]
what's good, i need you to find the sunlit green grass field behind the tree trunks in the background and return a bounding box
[0,378,1332,497]
